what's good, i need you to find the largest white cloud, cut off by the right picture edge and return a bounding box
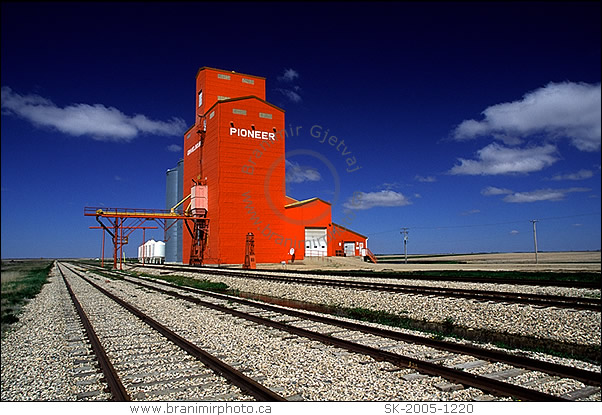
[453,82,601,151]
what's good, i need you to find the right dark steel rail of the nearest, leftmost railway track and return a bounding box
[67,267,286,401]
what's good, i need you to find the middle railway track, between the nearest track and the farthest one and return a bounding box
[71,262,600,401]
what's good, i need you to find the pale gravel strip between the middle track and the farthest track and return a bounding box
[137,268,602,345]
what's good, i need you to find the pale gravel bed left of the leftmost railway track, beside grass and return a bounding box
[2,265,102,401]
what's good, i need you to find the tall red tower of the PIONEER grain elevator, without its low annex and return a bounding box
[182,67,286,264]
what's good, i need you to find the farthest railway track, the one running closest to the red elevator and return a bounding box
[134,264,602,311]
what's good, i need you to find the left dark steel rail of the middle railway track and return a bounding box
[82,268,567,401]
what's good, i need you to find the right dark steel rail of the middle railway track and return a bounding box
[119,276,602,386]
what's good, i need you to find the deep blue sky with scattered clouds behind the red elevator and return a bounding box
[1,2,601,258]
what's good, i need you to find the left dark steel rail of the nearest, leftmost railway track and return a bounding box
[57,262,132,402]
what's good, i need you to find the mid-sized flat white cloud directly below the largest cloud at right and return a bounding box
[449,143,558,176]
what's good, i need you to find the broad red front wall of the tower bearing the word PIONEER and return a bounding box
[211,98,286,263]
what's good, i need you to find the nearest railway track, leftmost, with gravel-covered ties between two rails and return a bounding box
[58,265,285,401]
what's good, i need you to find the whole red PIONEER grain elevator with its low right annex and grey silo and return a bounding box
[166,67,373,264]
